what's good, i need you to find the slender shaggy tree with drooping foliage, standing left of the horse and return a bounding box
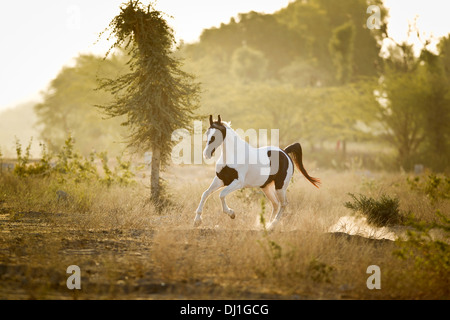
[99,0,199,204]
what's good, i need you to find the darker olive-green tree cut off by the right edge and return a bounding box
[378,38,450,171]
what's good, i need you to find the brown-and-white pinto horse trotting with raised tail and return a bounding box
[194,115,320,230]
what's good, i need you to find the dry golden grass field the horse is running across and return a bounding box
[0,166,450,299]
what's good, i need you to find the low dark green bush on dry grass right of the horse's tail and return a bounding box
[344,193,404,227]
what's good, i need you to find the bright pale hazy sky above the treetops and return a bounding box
[0,0,450,109]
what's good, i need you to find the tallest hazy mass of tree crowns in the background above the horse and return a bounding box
[184,0,386,86]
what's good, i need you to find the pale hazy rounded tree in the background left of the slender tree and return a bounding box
[34,54,127,155]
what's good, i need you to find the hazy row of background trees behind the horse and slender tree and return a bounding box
[2,0,450,171]
